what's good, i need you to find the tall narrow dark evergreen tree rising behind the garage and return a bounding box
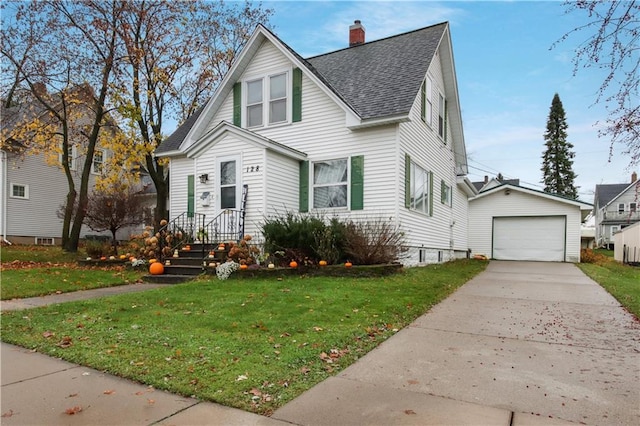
[541,93,578,200]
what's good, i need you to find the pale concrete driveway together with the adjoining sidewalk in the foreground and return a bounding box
[1,262,640,426]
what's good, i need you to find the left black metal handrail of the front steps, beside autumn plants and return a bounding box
[158,212,206,259]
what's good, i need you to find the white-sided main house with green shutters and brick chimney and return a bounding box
[155,21,477,264]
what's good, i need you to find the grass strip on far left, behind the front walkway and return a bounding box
[0,263,144,300]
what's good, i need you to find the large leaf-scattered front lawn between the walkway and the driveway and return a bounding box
[2,260,487,414]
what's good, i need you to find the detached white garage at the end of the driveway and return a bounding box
[469,184,592,262]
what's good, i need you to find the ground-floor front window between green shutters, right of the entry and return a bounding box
[313,158,349,209]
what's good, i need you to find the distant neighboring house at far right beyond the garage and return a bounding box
[594,172,640,248]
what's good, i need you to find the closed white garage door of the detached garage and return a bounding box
[492,216,566,262]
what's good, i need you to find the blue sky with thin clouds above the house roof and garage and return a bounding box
[263,1,632,203]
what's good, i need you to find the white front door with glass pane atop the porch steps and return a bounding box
[214,156,242,240]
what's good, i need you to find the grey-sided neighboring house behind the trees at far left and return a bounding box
[0,87,152,245]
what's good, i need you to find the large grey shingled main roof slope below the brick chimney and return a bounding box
[307,23,447,120]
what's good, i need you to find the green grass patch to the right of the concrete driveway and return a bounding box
[578,250,640,318]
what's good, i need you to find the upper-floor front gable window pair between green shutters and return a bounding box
[246,72,289,128]
